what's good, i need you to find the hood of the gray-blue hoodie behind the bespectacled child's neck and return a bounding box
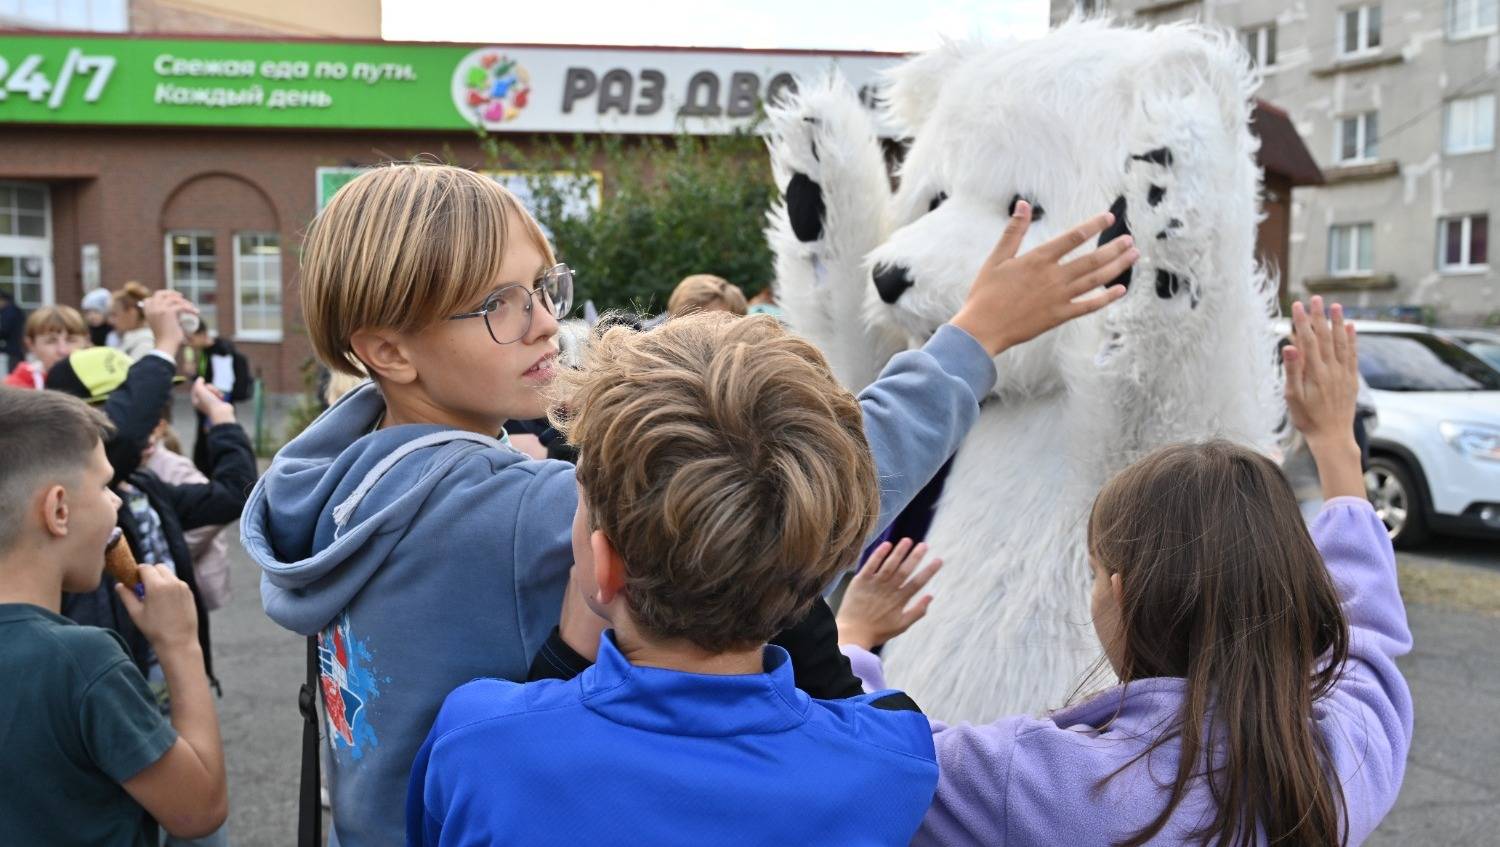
[240,384,510,636]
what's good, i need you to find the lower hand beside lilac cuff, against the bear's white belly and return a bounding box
[837,538,942,651]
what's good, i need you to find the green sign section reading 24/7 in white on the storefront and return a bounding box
[0,34,474,129]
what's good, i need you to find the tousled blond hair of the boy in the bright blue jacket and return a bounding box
[554,312,879,652]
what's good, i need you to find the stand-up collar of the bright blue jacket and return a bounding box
[579,631,812,738]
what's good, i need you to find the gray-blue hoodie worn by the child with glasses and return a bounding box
[240,325,995,847]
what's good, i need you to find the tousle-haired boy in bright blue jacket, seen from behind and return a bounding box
[407,315,938,847]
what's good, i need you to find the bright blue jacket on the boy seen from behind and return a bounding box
[407,633,938,847]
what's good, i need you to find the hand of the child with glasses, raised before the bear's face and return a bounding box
[953,201,1140,355]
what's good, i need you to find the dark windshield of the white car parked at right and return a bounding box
[1359,333,1500,391]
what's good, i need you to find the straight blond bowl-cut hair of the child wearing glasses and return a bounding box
[302,162,557,375]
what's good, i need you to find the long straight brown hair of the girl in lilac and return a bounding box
[1089,441,1349,847]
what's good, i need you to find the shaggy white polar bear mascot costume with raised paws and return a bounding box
[768,21,1284,721]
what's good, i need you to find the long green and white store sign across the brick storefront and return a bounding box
[0,34,900,135]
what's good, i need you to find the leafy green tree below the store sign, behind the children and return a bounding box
[485,132,776,313]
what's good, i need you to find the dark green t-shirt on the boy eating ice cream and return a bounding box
[0,603,177,847]
